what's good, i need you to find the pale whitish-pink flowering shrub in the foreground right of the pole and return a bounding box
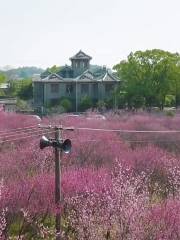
[66,162,148,240]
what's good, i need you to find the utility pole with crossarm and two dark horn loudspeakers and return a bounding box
[40,125,74,240]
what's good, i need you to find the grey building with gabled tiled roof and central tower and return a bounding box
[33,51,120,111]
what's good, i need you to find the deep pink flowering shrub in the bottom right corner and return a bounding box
[141,199,180,240]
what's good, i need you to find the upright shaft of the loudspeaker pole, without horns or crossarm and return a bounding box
[55,128,62,240]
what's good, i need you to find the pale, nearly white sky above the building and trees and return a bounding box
[0,0,180,68]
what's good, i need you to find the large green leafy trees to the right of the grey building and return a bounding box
[113,49,180,109]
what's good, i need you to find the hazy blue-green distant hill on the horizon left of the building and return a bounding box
[0,67,44,80]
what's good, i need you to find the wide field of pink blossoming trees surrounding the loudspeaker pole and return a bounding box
[0,112,180,240]
